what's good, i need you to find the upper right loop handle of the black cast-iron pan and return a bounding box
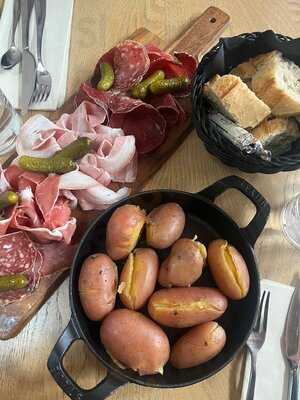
[198,175,270,247]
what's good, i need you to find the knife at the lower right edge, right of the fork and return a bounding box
[285,284,300,400]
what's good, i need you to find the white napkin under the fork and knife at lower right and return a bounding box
[241,279,294,400]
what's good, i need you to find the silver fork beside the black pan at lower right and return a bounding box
[246,290,270,400]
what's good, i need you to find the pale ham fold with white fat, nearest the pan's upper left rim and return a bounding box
[75,184,130,210]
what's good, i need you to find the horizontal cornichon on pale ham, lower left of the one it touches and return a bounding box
[18,156,76,174]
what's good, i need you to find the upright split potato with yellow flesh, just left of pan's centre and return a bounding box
[118,249,159,310]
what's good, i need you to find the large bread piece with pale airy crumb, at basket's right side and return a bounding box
[252,52,300,117]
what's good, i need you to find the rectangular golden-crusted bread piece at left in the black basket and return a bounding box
[203,75,271,128]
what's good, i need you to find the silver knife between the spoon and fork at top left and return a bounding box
[21,0,36,115]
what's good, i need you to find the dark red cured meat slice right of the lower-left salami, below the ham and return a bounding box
[36,242,77,277]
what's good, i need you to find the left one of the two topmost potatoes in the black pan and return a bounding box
[106,204,146,260]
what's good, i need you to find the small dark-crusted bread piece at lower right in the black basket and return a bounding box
[252,118,300,150]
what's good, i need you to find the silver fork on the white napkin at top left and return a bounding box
[31,0,52,103]
